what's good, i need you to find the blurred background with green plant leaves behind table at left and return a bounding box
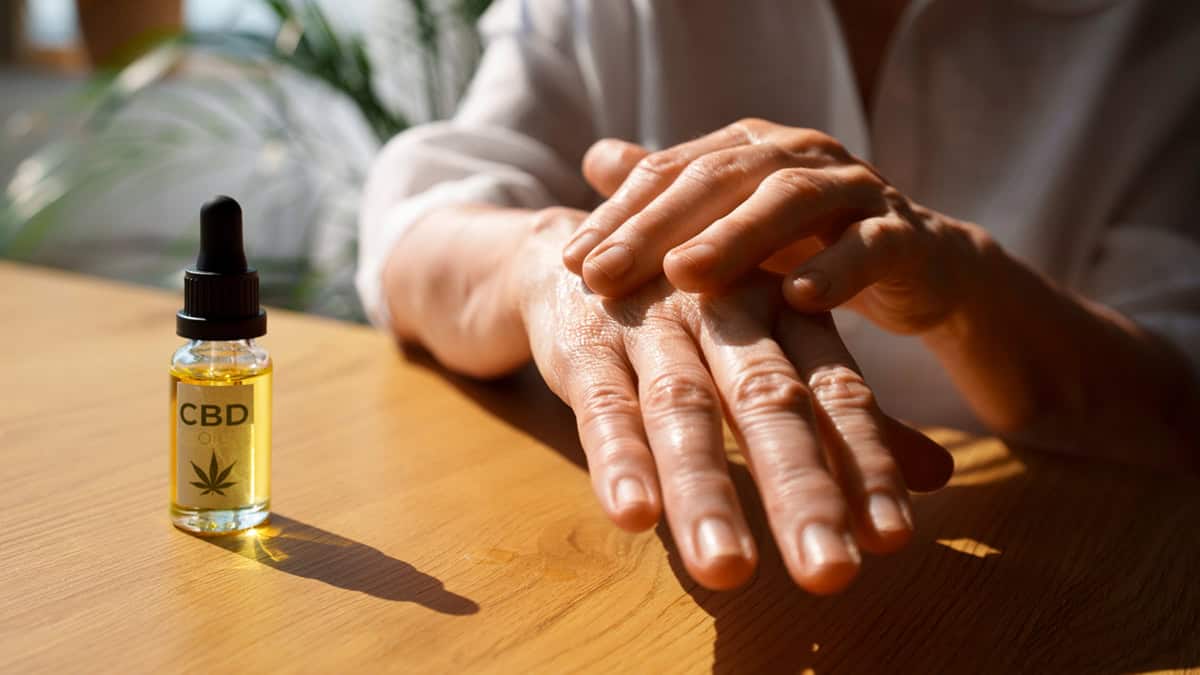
[0,0,491,321]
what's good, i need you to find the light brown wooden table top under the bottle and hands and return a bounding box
[0,263,1200,673]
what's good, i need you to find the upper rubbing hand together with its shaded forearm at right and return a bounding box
[563,119,1200,461]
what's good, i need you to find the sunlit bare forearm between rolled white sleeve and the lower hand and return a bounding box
[383,205,533,377]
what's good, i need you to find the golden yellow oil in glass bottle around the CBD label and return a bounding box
[168,364,272,534]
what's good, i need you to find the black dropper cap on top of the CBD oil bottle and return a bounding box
[175,196,266,340]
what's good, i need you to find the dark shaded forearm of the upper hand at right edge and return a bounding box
[924,234,1200,467]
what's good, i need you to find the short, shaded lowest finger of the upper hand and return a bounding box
[784,215,913,312]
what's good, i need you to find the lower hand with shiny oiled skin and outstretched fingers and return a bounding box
[510,209,953,593]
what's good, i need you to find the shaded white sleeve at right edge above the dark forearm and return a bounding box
[1082,225,1200,377]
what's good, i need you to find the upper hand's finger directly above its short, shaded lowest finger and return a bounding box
[662,165,887,292]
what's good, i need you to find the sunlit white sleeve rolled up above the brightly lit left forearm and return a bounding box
[355,0,596,328]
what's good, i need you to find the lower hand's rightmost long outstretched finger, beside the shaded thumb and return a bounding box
[779,312,946,552]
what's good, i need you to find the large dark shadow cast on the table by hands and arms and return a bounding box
[408,352,1200,673]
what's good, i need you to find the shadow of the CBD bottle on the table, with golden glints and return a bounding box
[203,514,479,615]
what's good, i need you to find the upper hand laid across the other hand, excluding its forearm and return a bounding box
[563,119,988,333]
